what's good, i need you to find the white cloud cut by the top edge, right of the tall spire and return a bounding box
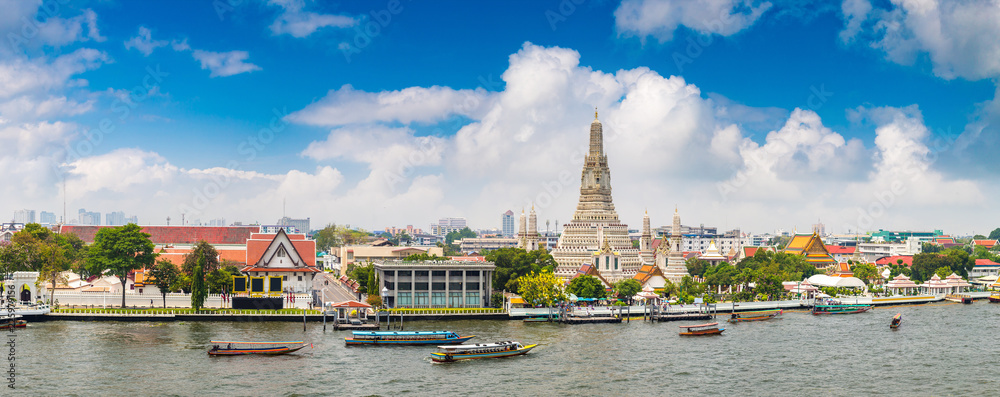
[615,0,771,42]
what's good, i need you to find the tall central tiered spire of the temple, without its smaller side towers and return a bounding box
[552,112,652,282]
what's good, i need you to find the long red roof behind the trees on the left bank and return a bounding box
[59,225,262,245]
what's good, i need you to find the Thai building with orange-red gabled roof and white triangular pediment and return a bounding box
[240,229,321,295]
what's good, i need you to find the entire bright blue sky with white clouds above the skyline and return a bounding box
[0,0,1000,234]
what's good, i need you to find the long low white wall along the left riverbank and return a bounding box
[45,291,312,309]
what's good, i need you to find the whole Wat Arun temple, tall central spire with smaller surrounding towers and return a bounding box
[518,112,687,287]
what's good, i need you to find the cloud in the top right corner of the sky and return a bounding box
[841,0,1000,80]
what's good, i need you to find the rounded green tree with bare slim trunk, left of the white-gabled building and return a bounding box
[87,223,156,308]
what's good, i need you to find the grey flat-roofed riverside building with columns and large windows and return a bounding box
[375,260,495,308]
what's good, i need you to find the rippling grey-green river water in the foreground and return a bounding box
[11,302,1000,396]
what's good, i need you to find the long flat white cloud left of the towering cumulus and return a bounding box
[288,85,491,126]
